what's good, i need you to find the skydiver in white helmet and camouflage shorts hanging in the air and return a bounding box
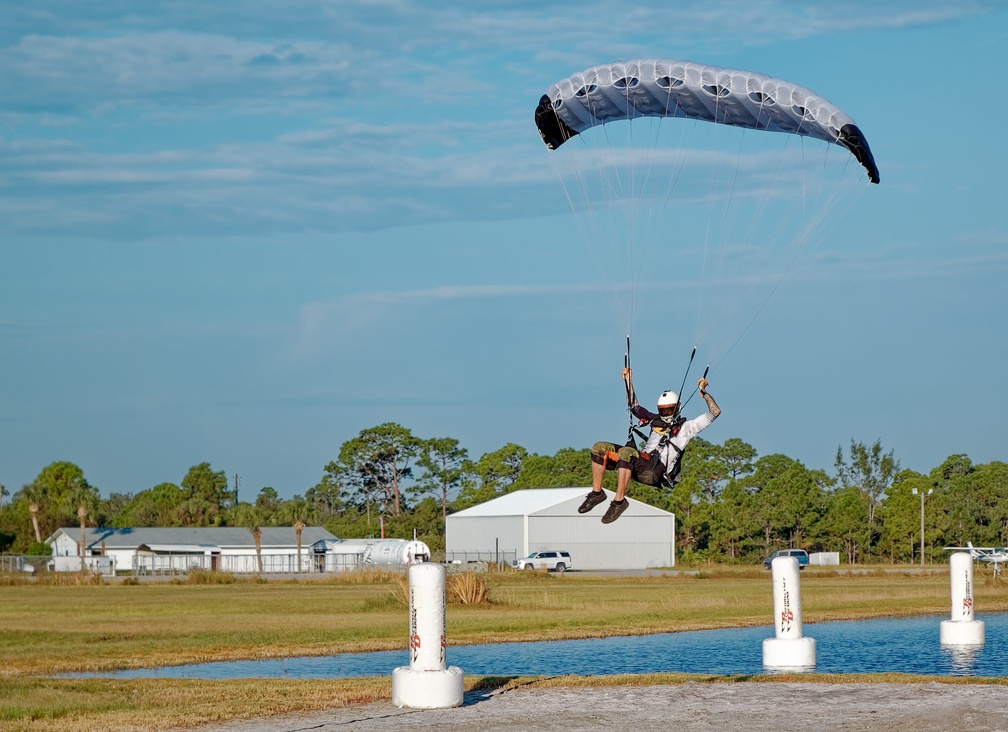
[578,368,721,523]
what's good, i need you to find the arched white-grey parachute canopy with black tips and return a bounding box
[535,58,879,184]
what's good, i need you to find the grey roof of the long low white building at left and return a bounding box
[45,526,336,550]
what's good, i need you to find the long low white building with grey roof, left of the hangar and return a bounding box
[45,526,336,575]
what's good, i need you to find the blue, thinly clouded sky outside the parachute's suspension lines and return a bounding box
[0,0,1008,500]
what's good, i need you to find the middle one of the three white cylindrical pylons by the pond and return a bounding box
[763,557,815,670]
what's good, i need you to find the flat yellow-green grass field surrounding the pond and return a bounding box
[0,568,1008,732]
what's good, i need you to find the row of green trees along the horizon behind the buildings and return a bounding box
[0,422,1008,564]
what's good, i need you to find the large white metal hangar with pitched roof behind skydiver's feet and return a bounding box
[445,488,675,570]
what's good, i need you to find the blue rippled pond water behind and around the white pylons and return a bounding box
[73,613,1008,679]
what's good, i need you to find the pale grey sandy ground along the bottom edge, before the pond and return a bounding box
[183,682,1008,732]
